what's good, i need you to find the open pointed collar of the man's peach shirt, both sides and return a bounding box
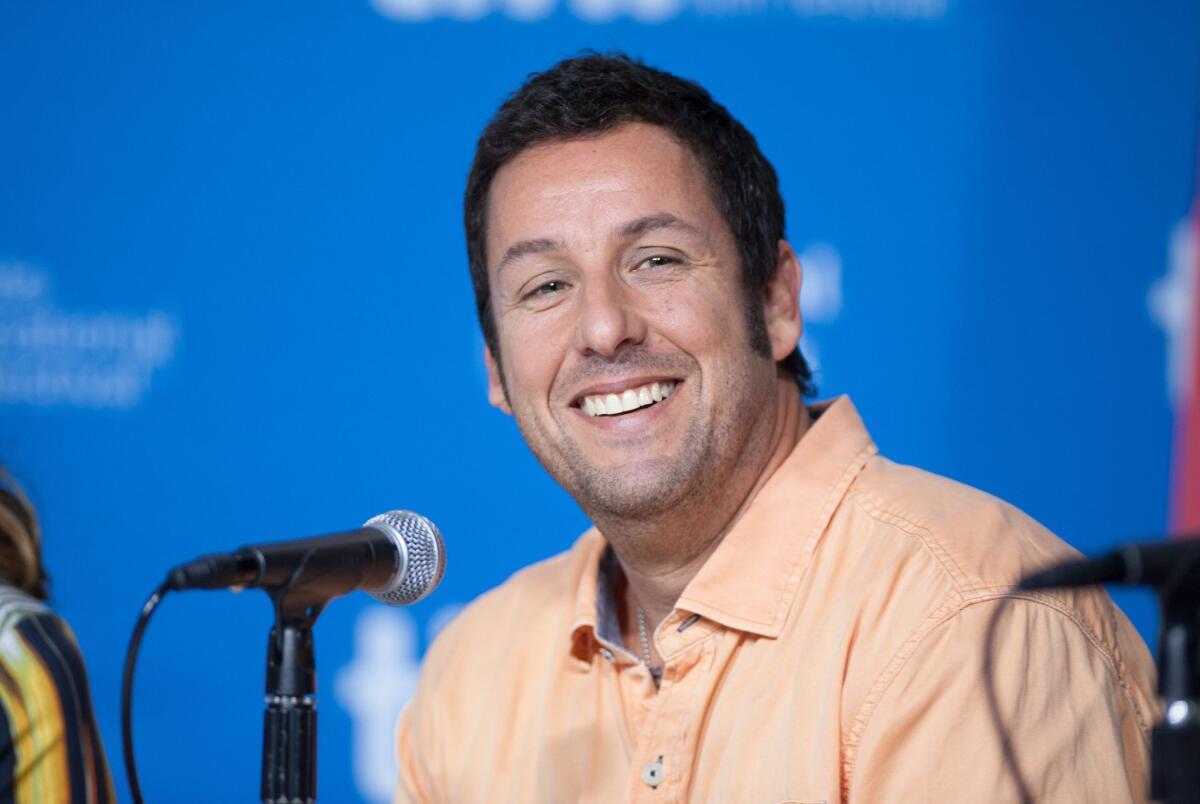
[571,396,877,661]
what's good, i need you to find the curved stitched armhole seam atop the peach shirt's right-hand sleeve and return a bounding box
[841,588,1150,791]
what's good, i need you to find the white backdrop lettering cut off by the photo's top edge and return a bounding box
[371,0,949,23]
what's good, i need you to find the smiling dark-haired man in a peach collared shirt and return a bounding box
[397,55,1156,802]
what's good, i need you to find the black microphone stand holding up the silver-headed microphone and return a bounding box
[260,576,328,804]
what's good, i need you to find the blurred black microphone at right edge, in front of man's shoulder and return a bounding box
[1018,539,1200,589]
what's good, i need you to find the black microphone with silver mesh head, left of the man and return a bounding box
[167,511,446,606]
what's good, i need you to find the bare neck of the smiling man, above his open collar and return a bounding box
[609,377,811,644]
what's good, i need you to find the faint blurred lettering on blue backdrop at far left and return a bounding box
[0,260,179,409]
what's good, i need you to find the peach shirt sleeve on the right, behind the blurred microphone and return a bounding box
[848,599,1150,804]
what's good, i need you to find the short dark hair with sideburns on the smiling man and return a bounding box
[463,54,814,395]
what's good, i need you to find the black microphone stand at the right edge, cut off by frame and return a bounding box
[1150,571,1200,804]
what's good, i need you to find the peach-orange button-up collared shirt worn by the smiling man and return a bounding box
[396,397,1157,804]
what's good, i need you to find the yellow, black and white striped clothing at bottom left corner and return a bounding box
[0,586,116,804]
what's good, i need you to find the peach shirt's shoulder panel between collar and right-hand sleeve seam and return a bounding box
[850,456,1079,594]
